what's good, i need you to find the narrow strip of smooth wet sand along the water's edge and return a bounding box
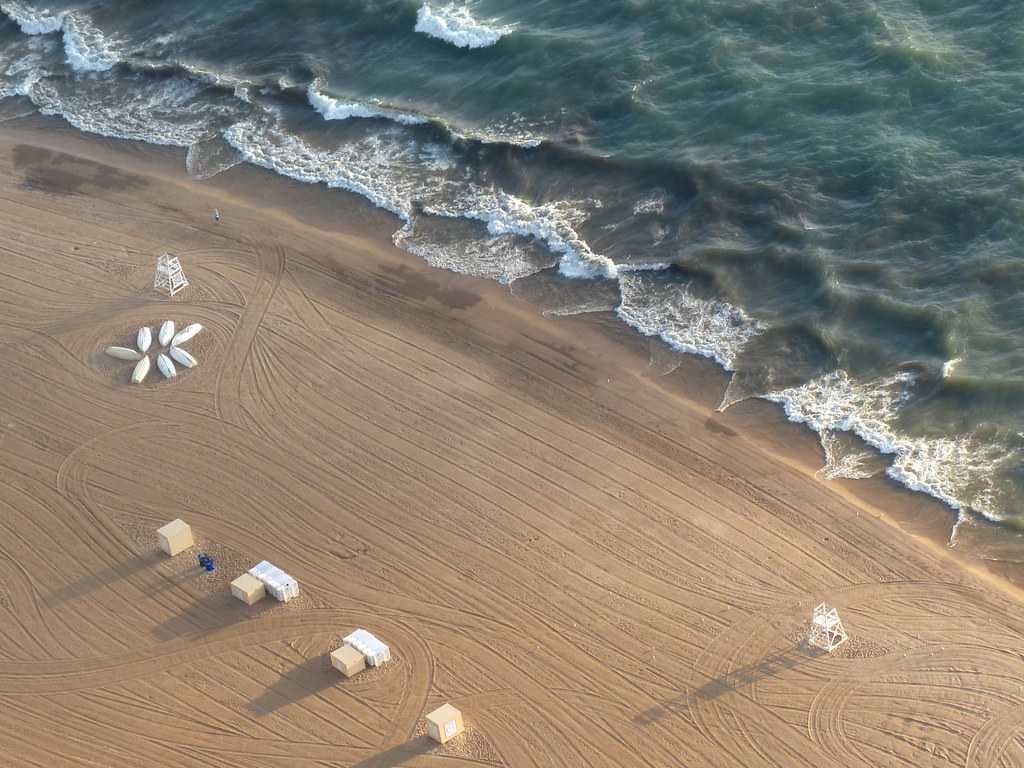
[0,115,1011,596]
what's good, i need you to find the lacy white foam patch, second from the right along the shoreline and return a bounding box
[615,271,764,371]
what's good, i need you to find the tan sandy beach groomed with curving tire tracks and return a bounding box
[0,115,1024,768]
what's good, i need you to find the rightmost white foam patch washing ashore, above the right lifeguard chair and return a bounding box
[762,371,1009,519]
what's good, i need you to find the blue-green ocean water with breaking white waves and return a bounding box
[0,0,1024,536]
